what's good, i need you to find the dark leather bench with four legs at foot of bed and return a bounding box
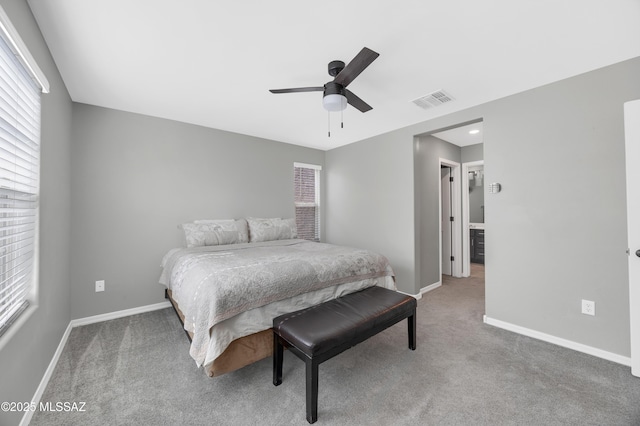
[273,287,417,423]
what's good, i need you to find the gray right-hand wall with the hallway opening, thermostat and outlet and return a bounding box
[327,58,640,356]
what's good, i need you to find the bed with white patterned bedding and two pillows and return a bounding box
[160,218,395,377]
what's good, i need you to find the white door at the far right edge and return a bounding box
[624,99,640,377]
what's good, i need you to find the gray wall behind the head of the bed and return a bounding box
[71,104,324,318]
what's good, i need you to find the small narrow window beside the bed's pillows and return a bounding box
[293,163,322,241]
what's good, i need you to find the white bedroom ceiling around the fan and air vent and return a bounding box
[28,0,640,150]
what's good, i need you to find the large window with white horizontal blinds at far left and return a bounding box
[0,9,48,335]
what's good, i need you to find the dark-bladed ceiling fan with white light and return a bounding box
[269,47,380,112]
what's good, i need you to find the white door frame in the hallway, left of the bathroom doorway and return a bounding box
[437,158,462,279]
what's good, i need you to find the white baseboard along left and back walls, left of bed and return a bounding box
[20,300,171,426]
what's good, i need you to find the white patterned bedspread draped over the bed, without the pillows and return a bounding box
[160,240,395,366]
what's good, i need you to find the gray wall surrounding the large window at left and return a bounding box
[0,0,71,425]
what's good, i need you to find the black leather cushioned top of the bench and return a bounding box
[273,286,417,357]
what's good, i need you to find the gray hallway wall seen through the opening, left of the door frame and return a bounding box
[414,135,461,288]
